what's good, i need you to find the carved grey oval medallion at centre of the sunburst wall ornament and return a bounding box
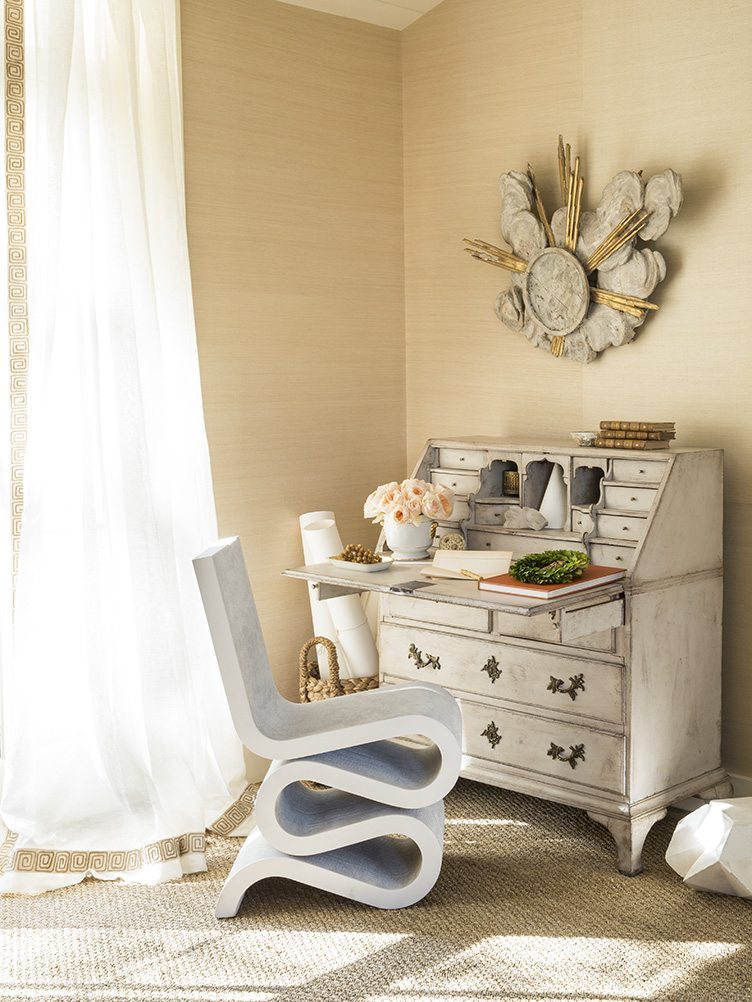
[522,247,591,337]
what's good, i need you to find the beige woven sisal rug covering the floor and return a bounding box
[0,781,752,1002]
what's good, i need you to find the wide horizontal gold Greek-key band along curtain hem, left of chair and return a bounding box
[0,832,207,874]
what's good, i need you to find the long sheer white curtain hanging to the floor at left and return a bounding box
[0,0,249,893]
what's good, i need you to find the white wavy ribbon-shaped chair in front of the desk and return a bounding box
[194,537,462,918]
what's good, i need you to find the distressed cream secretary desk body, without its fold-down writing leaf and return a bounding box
[379,438,728,874]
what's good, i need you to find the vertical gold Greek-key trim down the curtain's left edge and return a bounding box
[4,0,29,574]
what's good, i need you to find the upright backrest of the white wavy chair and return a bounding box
[194,536,292,755]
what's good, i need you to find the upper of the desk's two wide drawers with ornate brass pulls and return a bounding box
[379,623,623,727]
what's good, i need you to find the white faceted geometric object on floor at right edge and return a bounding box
[666,797,752,898]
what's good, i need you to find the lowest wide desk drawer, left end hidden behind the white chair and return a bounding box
[460,699,625,794]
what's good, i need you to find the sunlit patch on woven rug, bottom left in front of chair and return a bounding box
[0,927,409,1002]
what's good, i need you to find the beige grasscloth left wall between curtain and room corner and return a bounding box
[181,0,405,697]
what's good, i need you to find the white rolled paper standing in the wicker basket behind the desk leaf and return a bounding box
[300,511,379,678]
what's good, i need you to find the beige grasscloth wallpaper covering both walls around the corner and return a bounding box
[182,0,752,777]
